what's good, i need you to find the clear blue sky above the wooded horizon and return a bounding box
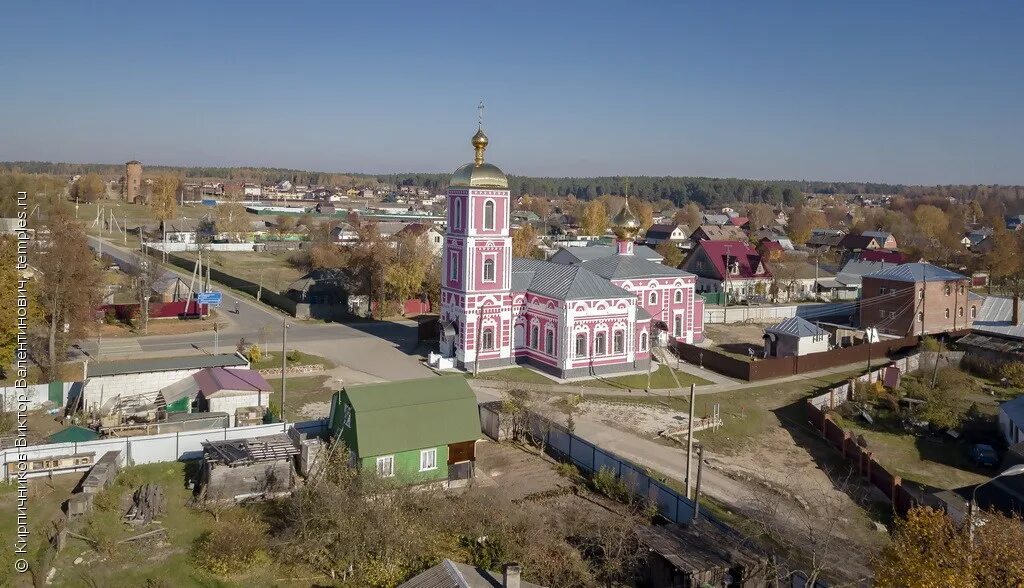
[0,0,1024,183]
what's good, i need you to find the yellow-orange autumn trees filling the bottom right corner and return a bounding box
[873,506,1024,588]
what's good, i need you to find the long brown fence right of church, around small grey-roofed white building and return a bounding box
[674,336,919,382]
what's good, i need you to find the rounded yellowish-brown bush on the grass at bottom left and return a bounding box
[193,509,268,576]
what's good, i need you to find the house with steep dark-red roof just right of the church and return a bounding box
[680,241,772,301]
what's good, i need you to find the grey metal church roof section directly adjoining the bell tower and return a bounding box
[512,257,633,300]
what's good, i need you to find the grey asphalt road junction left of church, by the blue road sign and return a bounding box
[80,237,433,383]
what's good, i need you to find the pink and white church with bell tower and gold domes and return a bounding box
[440,130,703,378]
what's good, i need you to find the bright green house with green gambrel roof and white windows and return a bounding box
[330,375,480,484]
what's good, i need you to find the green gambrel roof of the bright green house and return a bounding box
[334,375,480,457]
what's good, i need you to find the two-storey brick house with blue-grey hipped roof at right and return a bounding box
[860,262,974,337]
